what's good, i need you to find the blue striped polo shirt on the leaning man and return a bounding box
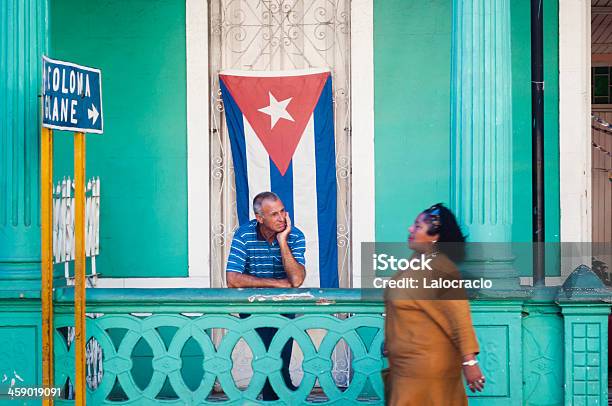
[226,220,306,279]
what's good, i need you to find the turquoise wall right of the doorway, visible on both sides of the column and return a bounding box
[374,0,559,247]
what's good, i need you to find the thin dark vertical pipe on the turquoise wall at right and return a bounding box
[531,0,545,286]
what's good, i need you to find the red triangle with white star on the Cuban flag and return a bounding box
[219,72,330,176]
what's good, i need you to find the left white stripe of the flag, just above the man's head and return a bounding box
[243,116,271,220]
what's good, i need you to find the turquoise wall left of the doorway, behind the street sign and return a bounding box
[50,0,186,277]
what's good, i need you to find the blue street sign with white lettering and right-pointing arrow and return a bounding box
[42,56,104,134]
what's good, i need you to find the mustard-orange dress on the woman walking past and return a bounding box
[385,254,479,406]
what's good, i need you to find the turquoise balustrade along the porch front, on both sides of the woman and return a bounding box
[40,278,610,406]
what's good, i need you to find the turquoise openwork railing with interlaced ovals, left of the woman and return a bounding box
[55,289,384,405]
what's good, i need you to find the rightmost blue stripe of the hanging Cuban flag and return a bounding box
[314,76,338,288]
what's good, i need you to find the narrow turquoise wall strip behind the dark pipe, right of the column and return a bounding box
[512,0,560,242]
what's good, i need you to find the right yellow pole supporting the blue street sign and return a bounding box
[74,133,87,406]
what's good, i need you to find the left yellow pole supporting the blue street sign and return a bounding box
[40,127,53,406]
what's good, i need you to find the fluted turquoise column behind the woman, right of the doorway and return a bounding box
[451,0,518,289]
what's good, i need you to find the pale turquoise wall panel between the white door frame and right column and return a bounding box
[374,0,451,241]
